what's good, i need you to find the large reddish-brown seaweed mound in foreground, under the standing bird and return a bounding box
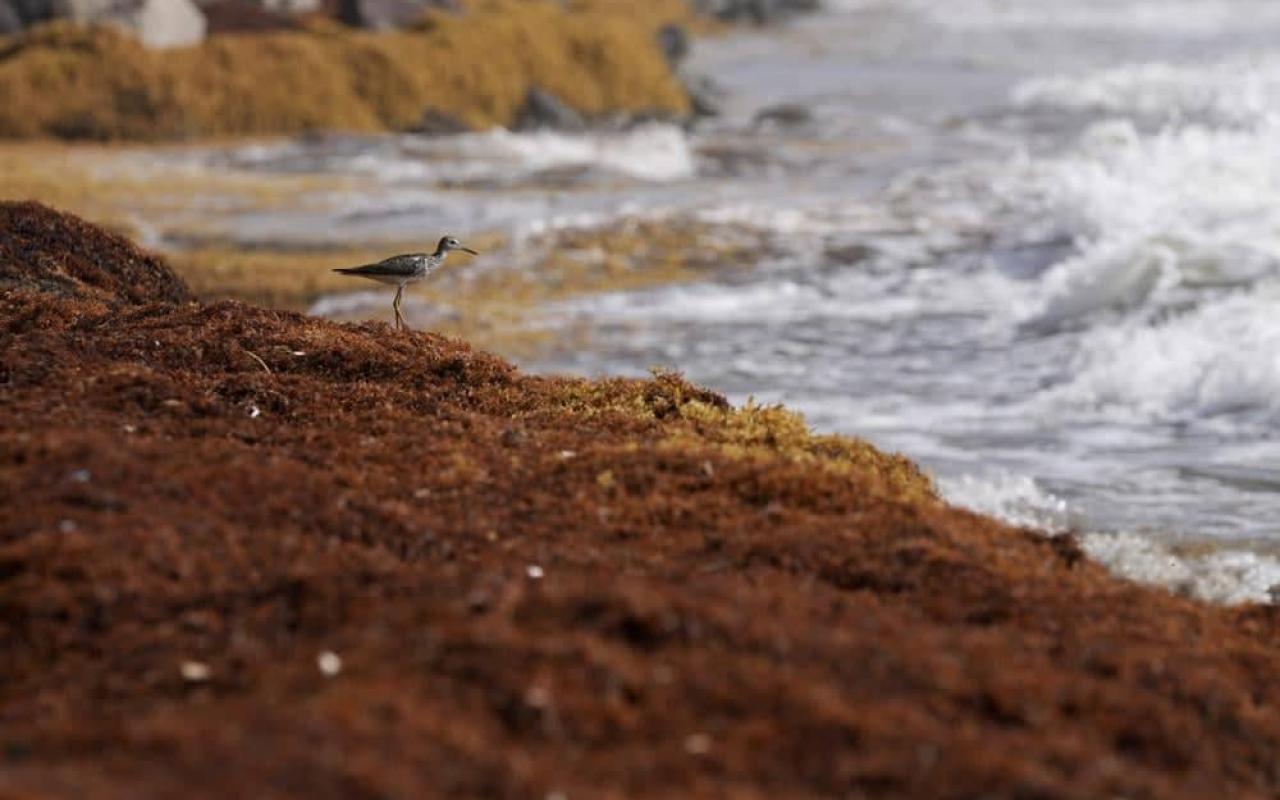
[0,204,1280,799]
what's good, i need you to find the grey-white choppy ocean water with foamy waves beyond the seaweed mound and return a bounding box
[117,0,1280,602]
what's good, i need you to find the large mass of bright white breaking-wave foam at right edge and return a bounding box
[931,122,1280,420]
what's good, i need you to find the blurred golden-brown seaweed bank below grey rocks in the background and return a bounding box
[0,0,689,141]
